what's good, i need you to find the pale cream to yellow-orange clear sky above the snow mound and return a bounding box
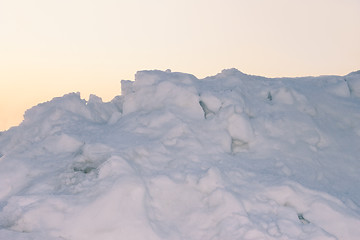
[0,0,360,131]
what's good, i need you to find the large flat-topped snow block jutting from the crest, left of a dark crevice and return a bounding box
[123,71,202,119]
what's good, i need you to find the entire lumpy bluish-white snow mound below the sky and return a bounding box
[0,69,360,240]
